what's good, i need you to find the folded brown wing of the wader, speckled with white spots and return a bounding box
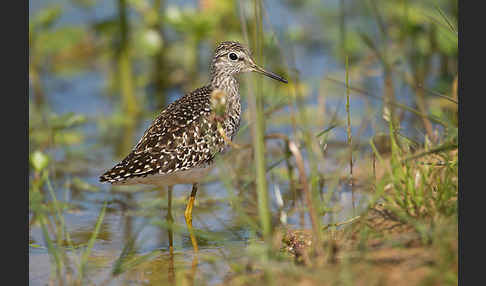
[100,87,224,183]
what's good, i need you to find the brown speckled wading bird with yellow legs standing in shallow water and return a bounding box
[100,41,288,251]
